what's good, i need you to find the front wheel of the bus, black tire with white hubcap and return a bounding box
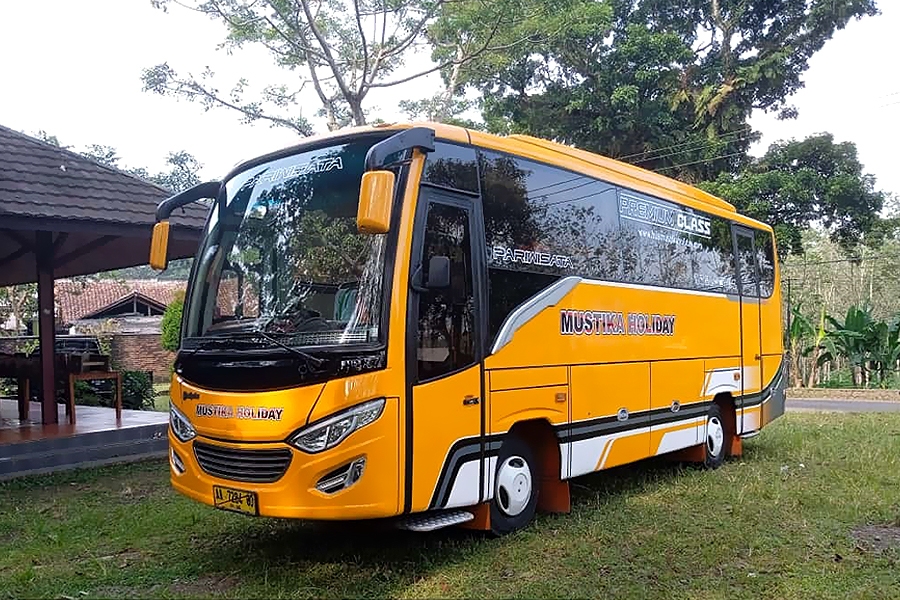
[491,435,540,536]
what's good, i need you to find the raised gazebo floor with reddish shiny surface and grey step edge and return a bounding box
[0,399,169,480]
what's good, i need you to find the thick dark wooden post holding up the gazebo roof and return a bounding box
[35,231,59,425]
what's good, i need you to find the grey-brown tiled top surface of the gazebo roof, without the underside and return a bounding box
[0,126,207,227]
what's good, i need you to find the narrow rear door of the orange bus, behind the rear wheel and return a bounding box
[732,227,762,432]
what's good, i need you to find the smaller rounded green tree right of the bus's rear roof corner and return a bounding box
[700,133,885,255]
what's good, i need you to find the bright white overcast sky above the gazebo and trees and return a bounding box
[0,0,900,194]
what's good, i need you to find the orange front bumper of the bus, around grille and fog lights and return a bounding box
[169,401,400,520]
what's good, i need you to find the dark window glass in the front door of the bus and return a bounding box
[416,203,475,381]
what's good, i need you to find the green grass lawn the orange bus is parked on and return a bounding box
[0,414,900,599]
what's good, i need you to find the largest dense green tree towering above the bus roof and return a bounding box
[436,0,877,182]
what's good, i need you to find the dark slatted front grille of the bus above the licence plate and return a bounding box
[194,441,291,483]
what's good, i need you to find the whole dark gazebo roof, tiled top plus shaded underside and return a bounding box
[0,126,208,286]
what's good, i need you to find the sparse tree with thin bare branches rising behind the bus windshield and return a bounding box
[142,0,536,131]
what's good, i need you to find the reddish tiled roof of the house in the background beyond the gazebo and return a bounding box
[55,279,186,324]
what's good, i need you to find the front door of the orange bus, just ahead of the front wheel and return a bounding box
[404,186,485,511]
